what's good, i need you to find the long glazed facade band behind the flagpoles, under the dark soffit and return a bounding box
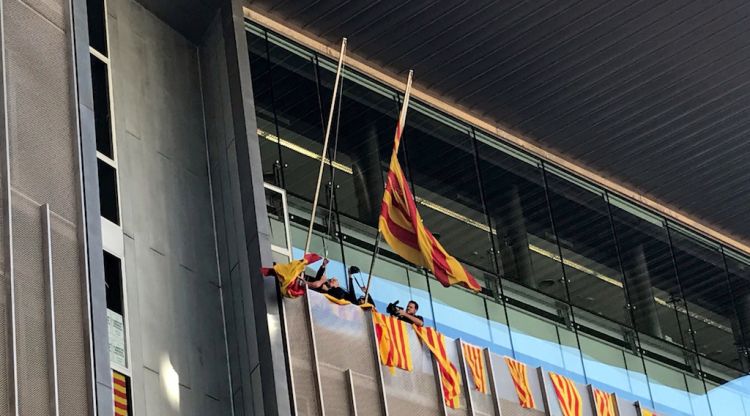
[247,21,750,415]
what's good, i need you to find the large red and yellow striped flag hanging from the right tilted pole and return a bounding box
[378,73,481,291]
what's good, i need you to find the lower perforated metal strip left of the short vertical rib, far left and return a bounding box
[13,193,50,416]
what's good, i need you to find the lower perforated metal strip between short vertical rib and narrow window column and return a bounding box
[50,215,91,415]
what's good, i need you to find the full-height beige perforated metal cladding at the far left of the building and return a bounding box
[0,0,92,415]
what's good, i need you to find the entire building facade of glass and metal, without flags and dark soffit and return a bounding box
[0,0,750,416]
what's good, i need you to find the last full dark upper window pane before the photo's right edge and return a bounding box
[670,229,741,368]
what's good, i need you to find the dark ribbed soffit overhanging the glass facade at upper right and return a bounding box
[248,0,750,242]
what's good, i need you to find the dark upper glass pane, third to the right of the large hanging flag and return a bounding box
[547,168,630,325]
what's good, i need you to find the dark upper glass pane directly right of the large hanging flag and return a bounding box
[403,103,495,278]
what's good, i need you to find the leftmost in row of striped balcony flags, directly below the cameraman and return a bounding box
[372,311,413,374]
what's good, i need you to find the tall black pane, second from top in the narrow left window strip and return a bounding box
[91,55,115,159]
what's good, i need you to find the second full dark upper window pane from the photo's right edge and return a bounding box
[610,197,687,345]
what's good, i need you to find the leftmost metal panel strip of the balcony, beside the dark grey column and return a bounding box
[284,299,319,416]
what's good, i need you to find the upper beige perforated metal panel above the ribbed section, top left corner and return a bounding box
[3,0,78,221]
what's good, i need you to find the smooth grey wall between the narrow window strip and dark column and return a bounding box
[107,0,231,415]
